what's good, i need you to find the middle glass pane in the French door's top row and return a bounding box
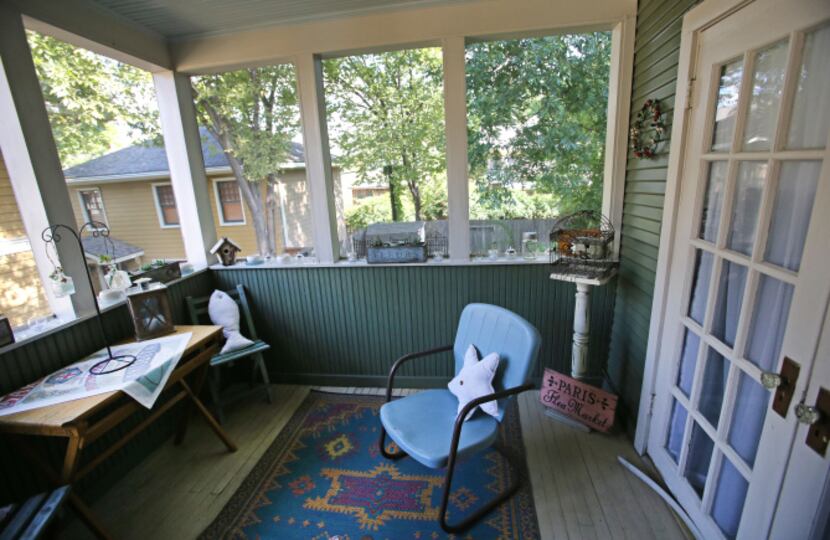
[744,41,788,150]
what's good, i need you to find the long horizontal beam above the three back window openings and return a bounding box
[170,0,637,73]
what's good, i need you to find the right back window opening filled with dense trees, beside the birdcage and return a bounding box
[465,32,611,259]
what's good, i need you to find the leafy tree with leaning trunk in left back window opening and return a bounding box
[192,65,300,255]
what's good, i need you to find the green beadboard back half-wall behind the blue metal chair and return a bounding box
[214,264,614,387]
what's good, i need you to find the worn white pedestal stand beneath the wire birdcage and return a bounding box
[545,267,617,432]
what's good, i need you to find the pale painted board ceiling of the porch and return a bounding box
[89,0,472,40]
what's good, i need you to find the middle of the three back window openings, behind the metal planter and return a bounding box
[323,48,449,259]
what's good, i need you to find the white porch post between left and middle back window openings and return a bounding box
[294,53,340,263]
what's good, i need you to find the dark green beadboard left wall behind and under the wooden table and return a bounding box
[0,271,218,506]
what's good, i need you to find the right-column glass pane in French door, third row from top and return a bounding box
[744,274,793,371]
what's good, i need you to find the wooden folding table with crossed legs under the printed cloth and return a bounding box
[0,326,236,538]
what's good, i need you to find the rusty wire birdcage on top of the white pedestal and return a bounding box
[550,210,617,278]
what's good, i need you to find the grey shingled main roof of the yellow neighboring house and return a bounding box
[63,128,305,179]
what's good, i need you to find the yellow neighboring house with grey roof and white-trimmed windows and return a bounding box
[64,129,324,268]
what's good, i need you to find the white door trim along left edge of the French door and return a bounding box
[634,0,752,455]
